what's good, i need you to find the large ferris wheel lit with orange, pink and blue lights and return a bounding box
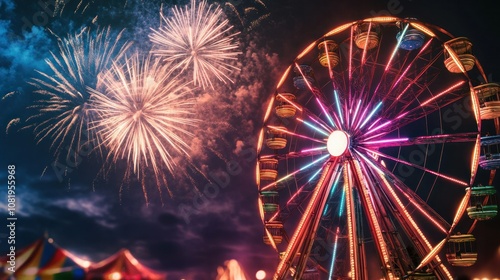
[256,17,500,279]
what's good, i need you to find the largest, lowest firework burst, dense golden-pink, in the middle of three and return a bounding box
[91,53,197,200]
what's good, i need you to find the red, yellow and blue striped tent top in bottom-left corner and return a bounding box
[2,238,90,280]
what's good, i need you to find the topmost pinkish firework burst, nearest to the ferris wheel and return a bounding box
[149,0,240,88]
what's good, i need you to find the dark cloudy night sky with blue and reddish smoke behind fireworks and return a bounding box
[0,0,500,279]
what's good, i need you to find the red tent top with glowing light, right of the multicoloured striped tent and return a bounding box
[87,249,166,280]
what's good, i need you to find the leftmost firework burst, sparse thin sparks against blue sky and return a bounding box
[27,28,130,162]
